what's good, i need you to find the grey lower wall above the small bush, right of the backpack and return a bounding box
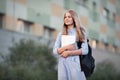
[93,49,120,70]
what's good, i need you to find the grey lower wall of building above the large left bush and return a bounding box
[0,29,50,54]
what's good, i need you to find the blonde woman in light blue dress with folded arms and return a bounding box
[53,10,88,80]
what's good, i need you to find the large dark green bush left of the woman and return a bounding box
[0,40,57,80]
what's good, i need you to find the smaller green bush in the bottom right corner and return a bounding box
[88,60,120,80]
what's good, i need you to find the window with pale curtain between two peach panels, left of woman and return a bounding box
[17,19,33,33]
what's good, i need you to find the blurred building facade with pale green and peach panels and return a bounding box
[0,0,120,53]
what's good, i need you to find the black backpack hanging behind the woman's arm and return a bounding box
[77,40,95,77]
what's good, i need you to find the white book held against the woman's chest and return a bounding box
[61,35,76,47]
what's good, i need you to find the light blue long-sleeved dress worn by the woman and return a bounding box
[53,28,88,80]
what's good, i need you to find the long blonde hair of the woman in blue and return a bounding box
[62,10,85,42]
